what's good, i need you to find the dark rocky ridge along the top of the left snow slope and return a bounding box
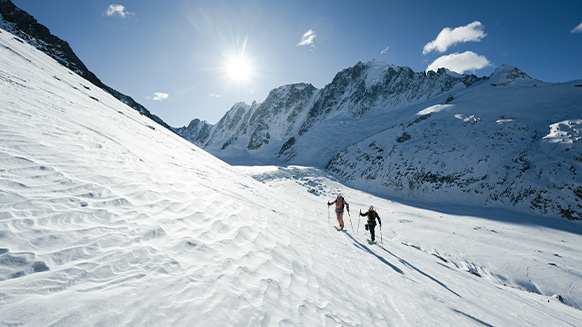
[0,0,170,129]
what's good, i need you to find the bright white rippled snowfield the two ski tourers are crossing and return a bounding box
[0,26,582,326]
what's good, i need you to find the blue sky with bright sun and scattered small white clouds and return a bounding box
[12,0,582,127]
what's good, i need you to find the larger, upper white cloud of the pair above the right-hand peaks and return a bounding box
[422,21,487,54]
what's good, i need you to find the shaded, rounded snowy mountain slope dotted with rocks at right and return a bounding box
[327,66,582,219]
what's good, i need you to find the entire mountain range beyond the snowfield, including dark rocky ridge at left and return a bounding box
[0,0,582,220]
